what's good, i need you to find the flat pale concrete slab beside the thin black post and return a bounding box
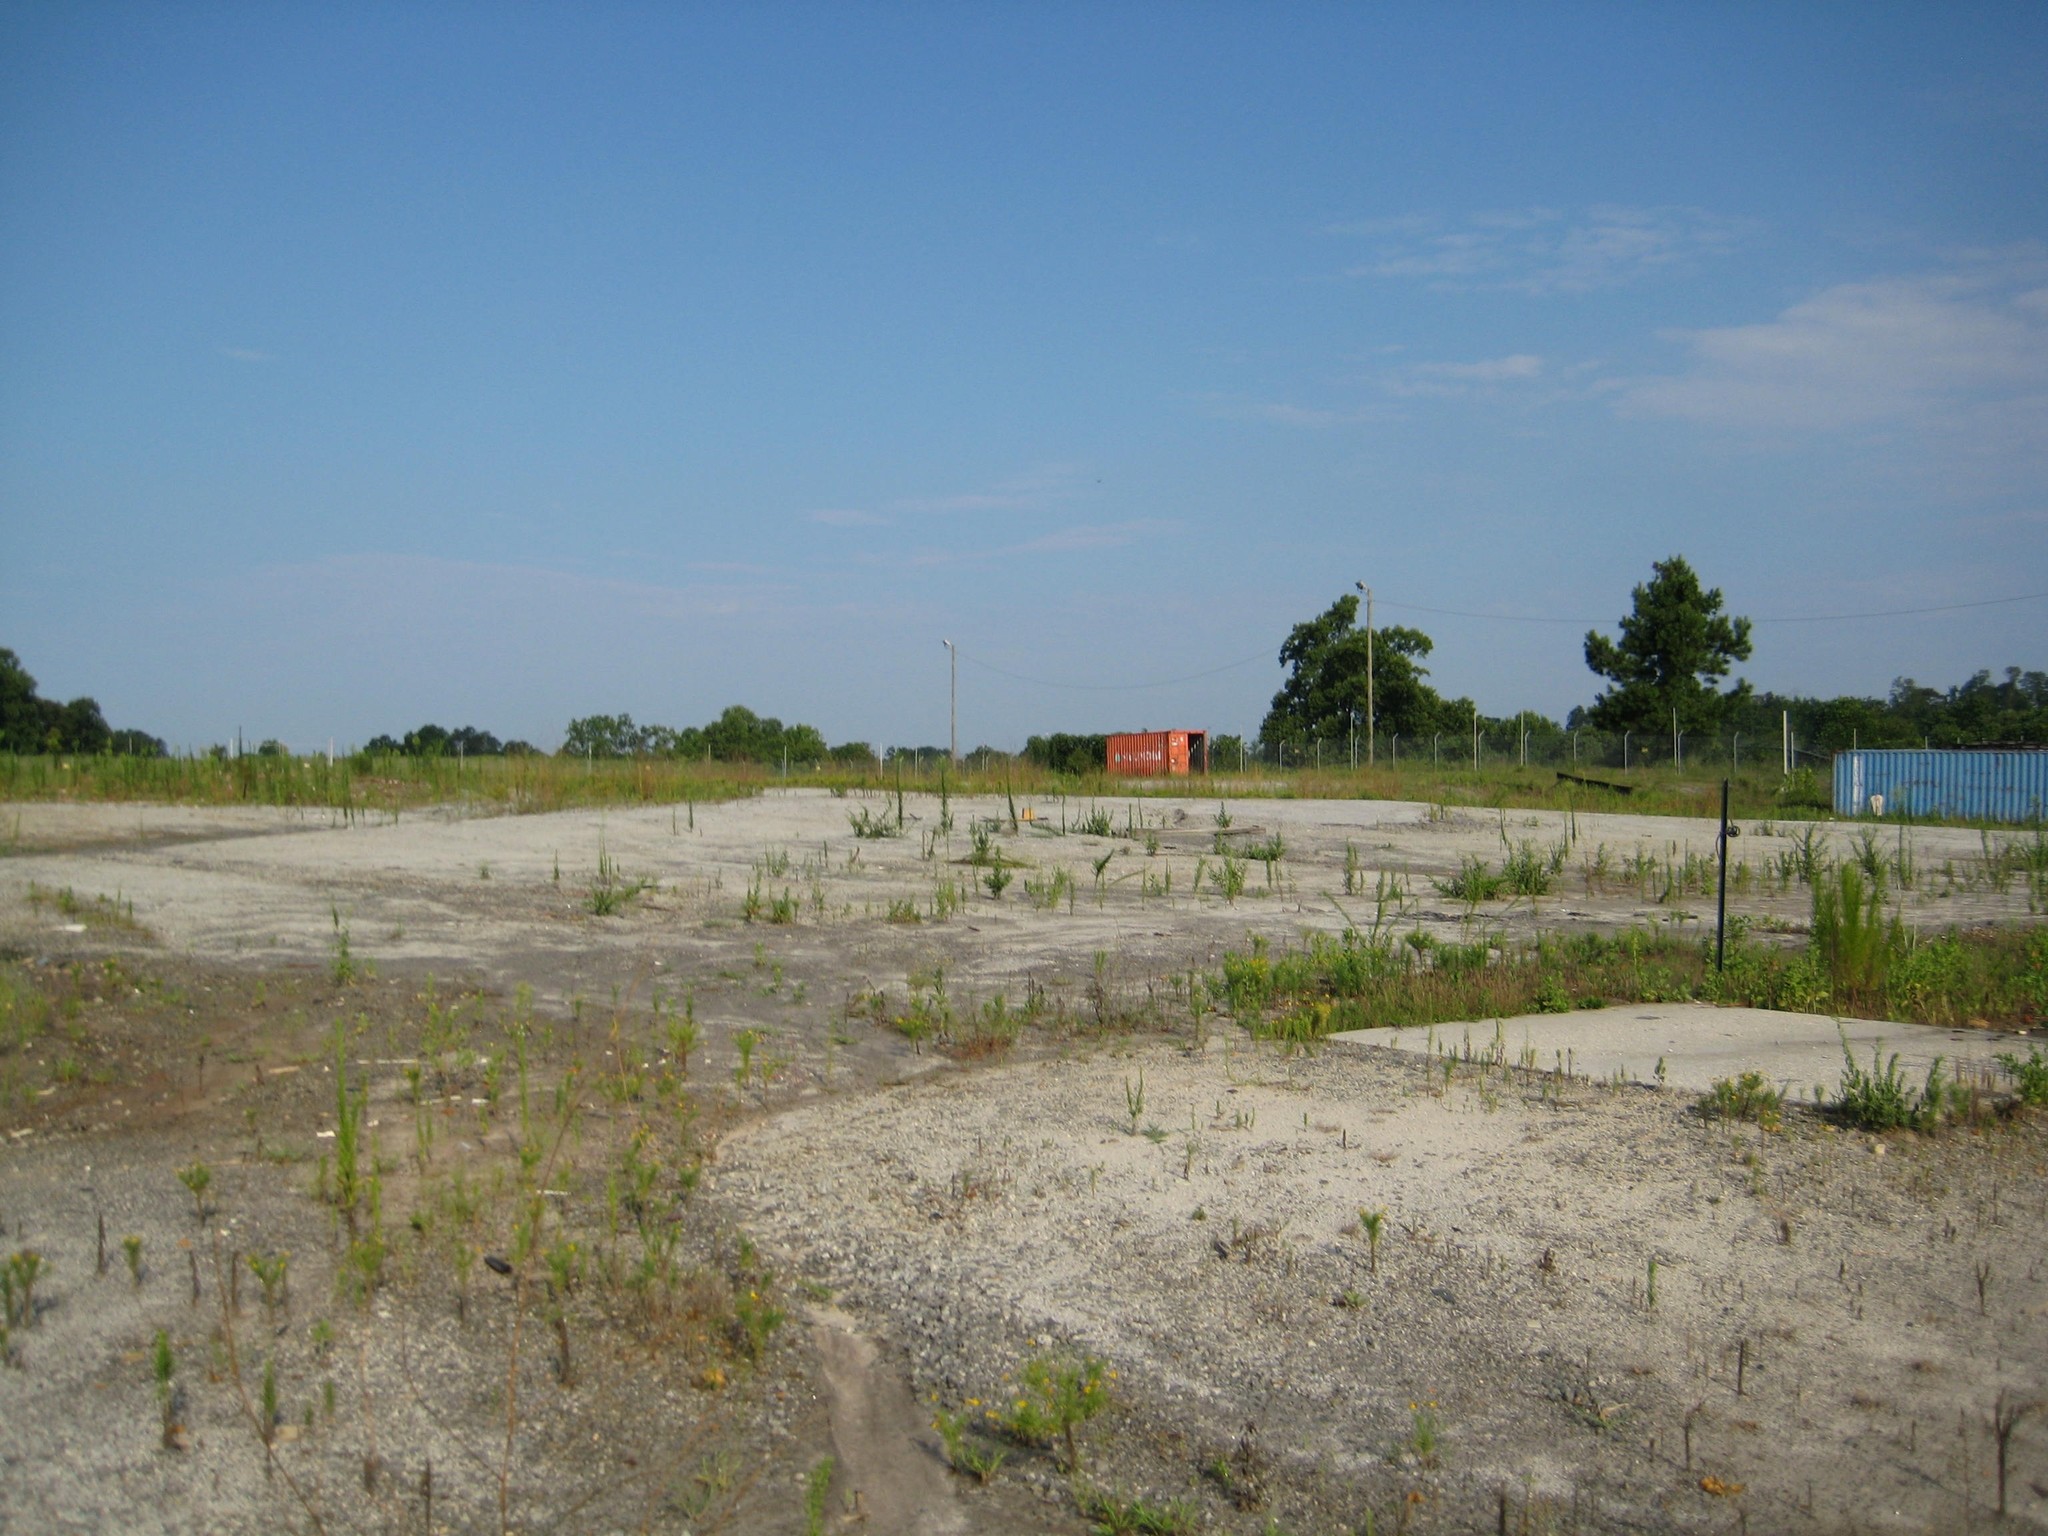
[1329,1004,2040,1100]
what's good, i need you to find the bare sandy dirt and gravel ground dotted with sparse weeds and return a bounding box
[0,793,2048,1536]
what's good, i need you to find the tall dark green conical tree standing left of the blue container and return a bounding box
[1585,555,1749,733]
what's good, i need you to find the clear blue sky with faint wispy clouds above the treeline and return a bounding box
[0,4,2048,748]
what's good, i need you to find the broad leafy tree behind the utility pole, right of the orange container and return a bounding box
[1260,594,1444,745]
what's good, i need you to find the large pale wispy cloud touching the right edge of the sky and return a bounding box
[1616,250,2048,434]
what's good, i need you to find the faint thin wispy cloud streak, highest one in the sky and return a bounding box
[1329,203,1755,295]
